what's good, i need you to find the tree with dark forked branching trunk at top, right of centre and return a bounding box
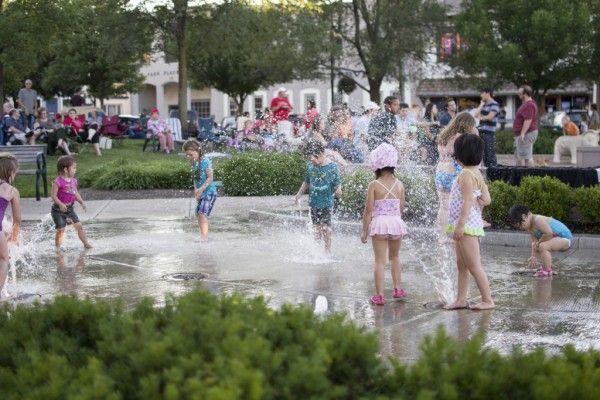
[339,0,445,103]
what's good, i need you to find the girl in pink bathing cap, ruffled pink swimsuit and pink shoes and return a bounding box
[361,143,406,305]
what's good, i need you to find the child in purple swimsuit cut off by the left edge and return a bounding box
[0,153,21,301]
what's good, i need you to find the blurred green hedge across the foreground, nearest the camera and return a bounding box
[0,290,600,400]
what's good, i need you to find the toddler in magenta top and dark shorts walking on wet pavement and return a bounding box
[50,156,92,249]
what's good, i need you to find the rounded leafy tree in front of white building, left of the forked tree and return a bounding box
[190,0,326,114]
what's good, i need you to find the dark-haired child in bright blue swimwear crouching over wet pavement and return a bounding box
[508,204,573,278]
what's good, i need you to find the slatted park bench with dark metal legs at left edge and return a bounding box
[0,144,48,201]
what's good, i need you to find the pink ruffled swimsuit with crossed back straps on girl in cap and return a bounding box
[369,181,407,240]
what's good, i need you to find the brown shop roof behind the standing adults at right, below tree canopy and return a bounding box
[417,78,592,97]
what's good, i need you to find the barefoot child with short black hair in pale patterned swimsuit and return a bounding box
[444,135,495,310]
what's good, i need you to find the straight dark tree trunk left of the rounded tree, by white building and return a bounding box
[173,0,188,135]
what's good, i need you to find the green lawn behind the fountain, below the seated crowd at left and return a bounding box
[15,139,187,197]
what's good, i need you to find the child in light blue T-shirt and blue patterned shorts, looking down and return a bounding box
[183,139,217,242]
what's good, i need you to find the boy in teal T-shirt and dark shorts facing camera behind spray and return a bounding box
[295,139,342,251]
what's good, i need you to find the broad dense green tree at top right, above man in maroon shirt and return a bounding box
[450,0,592,97]
